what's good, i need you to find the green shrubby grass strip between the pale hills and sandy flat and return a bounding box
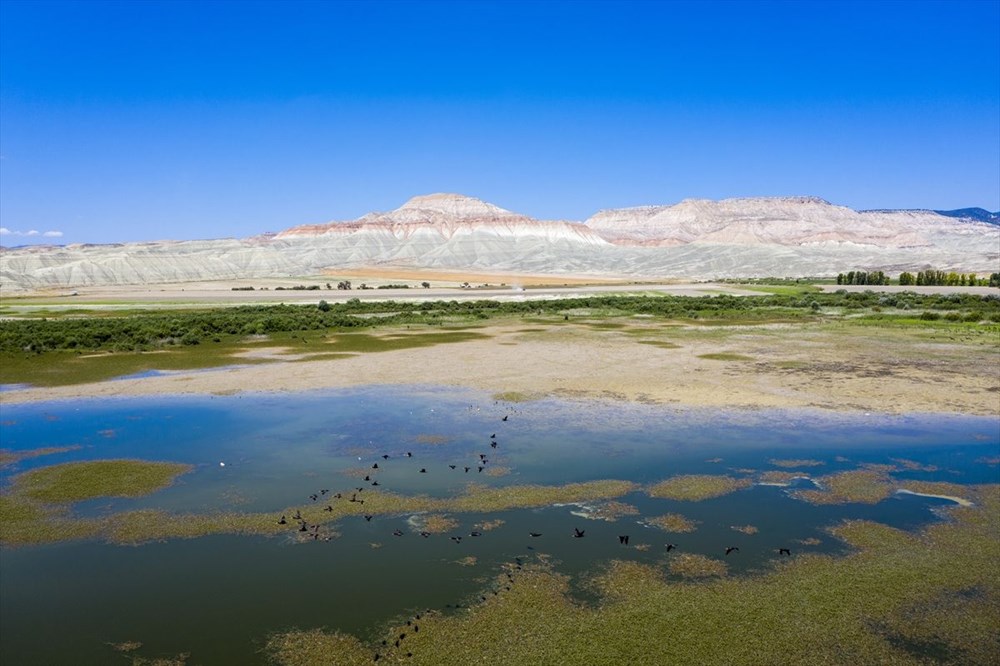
[0,285,1000,386]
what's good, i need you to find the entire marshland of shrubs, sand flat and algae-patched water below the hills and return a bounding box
[0,287,1000,664]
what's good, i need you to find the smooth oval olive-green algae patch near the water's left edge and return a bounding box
[14,460,194,503]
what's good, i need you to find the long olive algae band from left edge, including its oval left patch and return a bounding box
[0,460,637,545]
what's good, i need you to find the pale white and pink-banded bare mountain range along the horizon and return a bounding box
[0,194,1000,293]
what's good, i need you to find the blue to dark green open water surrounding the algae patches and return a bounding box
[0,387,1000,664]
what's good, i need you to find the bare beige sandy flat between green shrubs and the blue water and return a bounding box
[2,318,1000,416]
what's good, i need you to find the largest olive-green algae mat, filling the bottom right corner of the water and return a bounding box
[267,486,1000,666]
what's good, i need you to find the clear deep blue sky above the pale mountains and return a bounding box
[0,0,1000,245]
